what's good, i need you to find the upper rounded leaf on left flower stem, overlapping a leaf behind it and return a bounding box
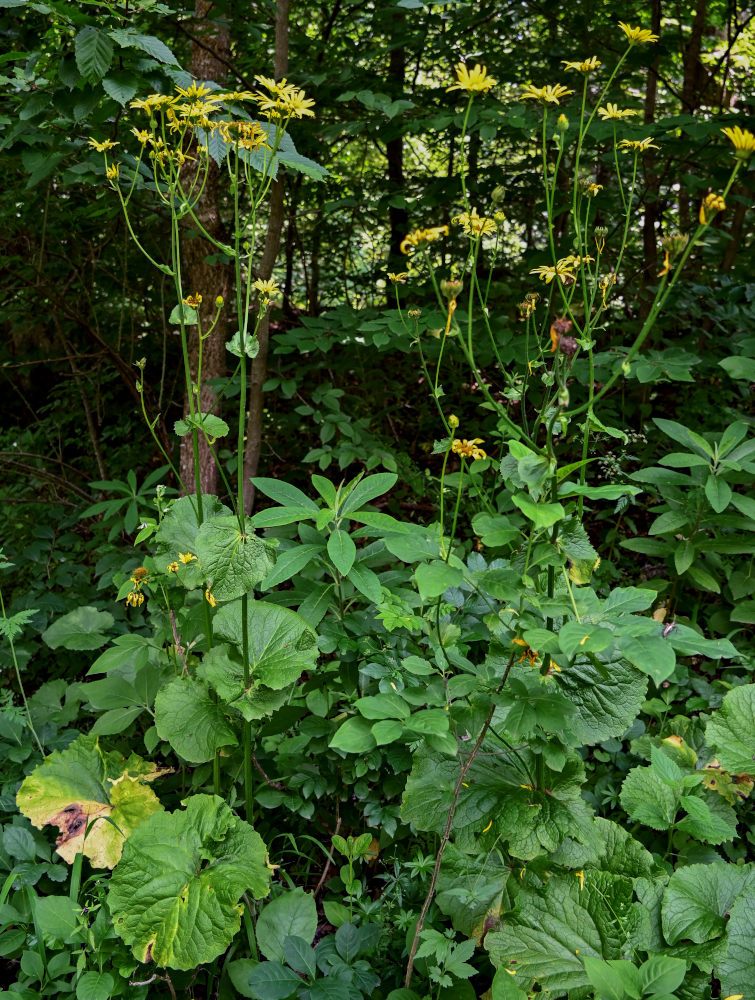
[196,515,275,601]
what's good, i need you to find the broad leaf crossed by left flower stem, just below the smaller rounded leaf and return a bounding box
[214,601,319,691]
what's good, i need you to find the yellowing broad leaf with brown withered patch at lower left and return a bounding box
[16,735,163,868]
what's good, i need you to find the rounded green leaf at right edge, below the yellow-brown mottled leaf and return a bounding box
[662,861,755,944]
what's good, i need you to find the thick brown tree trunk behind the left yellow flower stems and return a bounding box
[179,0,233,494]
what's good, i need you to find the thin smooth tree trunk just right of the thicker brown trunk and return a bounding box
[244,0,290,514]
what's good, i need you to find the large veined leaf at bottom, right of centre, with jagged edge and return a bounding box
[485,869,637,994]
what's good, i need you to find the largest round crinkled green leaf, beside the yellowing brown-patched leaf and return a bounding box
[108,795,271,969]
